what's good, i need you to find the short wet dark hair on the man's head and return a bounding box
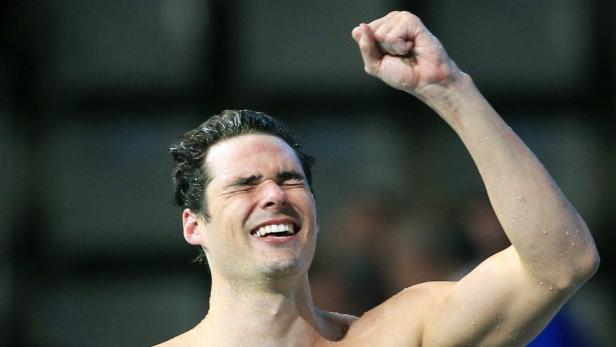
[169,110,314,261]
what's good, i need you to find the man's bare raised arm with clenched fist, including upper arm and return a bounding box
[352,12,599,346]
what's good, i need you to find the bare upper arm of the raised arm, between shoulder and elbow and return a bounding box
[423,247,567,346]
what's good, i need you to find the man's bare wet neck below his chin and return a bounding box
[197,273,322,346]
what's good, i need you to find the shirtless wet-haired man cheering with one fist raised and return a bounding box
[156,12,599,346]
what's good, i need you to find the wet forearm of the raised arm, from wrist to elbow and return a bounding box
[419,74,598,288]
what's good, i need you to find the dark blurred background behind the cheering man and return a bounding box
[0,0,616,346]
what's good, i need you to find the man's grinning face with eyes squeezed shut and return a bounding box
[202,134,318,280]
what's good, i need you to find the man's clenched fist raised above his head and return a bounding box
[352,11,461,99]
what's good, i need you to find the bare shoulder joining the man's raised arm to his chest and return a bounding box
[345,282,456,346]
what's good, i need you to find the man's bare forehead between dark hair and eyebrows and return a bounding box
[204,134,303,179]
